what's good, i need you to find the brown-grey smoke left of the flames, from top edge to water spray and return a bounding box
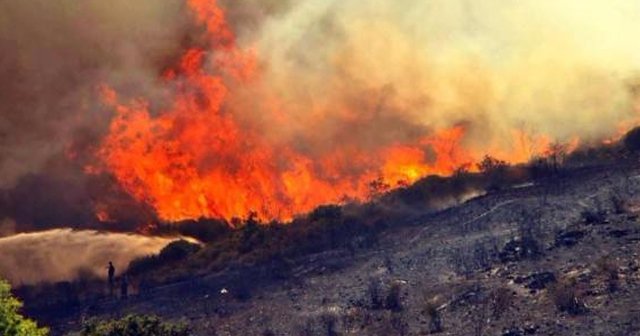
[0,0,197,231]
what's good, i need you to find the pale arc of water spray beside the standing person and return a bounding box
[0,229,178,285]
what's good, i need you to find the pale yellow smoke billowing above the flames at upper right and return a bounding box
[228,0,640,160]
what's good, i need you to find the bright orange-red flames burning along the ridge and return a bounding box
[92,0,628,226]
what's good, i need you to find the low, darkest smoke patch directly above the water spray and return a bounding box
[0,155,156,237]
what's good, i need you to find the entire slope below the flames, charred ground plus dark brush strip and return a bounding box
[13,138,640,335]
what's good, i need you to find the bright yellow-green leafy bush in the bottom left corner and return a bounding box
[0,280,49,336]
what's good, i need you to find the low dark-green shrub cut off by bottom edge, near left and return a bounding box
[80,315,192,336]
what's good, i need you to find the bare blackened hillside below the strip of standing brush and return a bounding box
[27,161,640,335]
